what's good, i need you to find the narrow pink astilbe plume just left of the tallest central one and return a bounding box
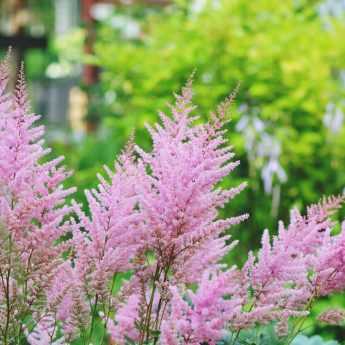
[74,143,143,295]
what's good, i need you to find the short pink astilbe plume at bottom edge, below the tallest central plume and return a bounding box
[161,269,242,345]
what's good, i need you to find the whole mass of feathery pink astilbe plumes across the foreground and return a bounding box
[0,57,345,345]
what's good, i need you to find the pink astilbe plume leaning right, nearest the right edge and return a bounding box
[239,197,344,328]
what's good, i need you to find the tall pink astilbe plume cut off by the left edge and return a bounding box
[0,56,73,344]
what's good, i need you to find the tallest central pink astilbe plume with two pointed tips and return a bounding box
[137,82,247,274]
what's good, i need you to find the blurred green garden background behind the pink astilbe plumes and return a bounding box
[0,0,345,340]
